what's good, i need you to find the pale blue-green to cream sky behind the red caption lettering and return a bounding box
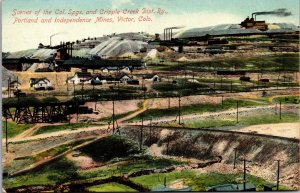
[2,0,299,52]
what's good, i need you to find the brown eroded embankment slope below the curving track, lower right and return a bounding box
[121,126,299,184]
